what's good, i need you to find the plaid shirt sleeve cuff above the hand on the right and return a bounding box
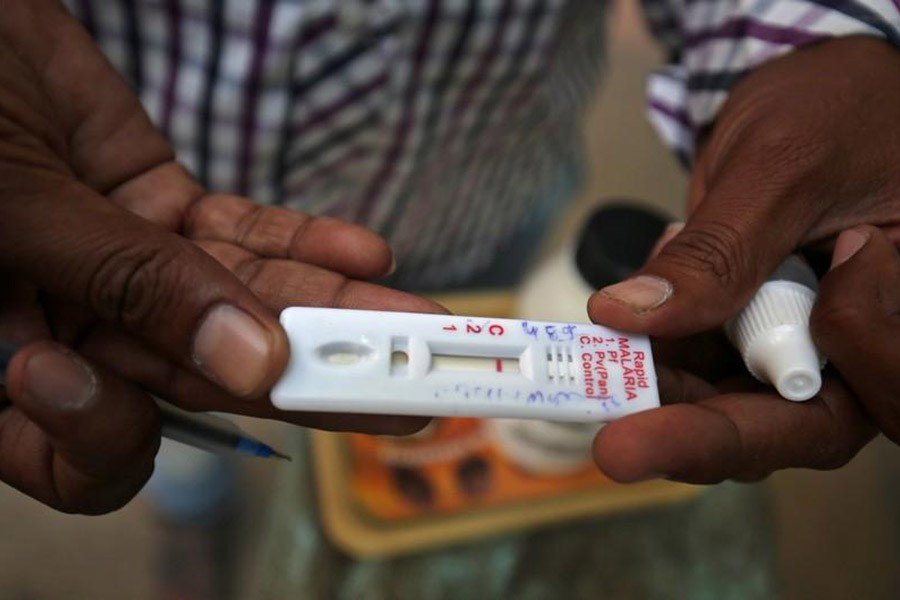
[641,0,900,162]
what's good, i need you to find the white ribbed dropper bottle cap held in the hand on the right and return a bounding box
[726,258,824,401]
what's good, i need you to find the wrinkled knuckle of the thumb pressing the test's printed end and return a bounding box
[660,223,753,287]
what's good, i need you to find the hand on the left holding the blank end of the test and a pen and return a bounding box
[0,0,442,513]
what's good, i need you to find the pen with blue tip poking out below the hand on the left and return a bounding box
[0,342,291,460]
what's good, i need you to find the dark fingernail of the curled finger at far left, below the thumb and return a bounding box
[23,348,97,409]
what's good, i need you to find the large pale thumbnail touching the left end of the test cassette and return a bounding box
[194,304,272,396]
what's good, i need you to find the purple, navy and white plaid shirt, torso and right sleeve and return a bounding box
[66,0,900,286]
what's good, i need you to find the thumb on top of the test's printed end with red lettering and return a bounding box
[588,191,803,336]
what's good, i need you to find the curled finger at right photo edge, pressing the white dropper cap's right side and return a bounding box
[810,226,900,443]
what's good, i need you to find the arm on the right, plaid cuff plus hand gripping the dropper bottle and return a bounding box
[589,1,900,482]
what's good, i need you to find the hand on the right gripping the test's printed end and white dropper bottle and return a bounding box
[589,38,900,483]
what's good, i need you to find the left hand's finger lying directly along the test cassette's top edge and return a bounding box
[198,241,447,314]
